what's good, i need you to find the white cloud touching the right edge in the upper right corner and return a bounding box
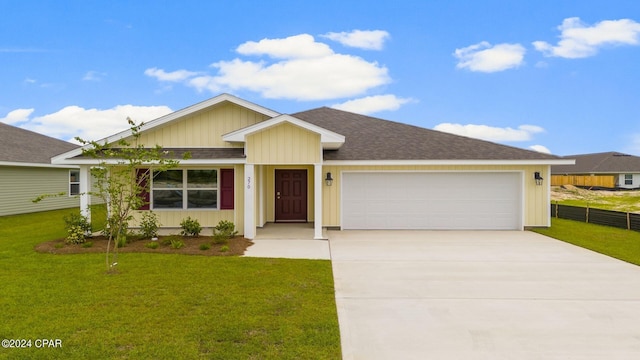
[533,17,640,59]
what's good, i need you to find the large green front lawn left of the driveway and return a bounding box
[0,210,341,359]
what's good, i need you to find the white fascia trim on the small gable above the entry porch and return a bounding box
[222,115,344,149]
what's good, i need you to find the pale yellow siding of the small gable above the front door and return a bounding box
[245,123,321,164]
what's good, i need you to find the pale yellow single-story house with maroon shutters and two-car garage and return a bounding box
[52,94,573,239]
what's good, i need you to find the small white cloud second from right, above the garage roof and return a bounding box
[453,41,526,73]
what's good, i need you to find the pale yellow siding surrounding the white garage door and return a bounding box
[322,165,551,227]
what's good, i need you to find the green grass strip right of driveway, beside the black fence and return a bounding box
[533,218,640,265]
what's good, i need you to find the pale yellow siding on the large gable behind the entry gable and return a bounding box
[134,103,269,148]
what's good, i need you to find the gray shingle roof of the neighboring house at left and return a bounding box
[0,122,78,164]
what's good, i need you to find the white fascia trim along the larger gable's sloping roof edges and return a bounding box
[51,94,280,164]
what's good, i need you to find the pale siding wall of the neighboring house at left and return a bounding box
[0,166,80,216]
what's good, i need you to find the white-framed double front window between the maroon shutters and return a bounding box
[151,170,218,209]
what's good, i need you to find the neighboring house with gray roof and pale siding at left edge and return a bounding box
[0,122,80,216]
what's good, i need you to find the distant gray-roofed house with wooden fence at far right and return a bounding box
[551,151,640,189]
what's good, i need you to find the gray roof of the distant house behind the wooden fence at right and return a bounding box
[551,151,640,174]
